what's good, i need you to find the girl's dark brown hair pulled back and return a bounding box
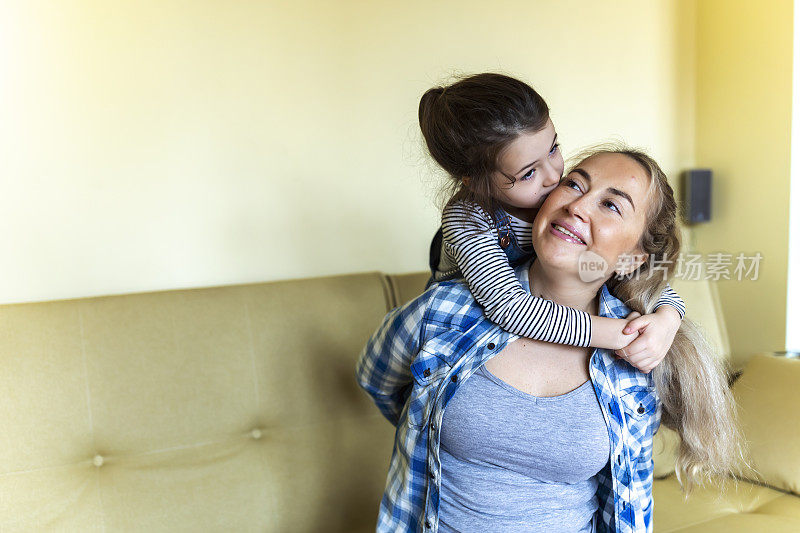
[419,73,550,219]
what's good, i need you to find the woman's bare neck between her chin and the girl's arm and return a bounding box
[528,260,603,315]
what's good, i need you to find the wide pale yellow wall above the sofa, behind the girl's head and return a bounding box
[0,0,692,302]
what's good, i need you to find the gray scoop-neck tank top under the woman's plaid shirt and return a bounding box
[439,365,610,533]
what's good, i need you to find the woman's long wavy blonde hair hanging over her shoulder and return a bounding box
[572,144,743,494]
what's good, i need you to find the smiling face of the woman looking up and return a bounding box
[533,154,650,281]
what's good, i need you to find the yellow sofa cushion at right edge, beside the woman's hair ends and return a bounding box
[733,354,800,494]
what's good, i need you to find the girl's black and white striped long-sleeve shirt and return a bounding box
[434,202,686,347]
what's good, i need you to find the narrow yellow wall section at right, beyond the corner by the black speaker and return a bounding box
[693,0,793,363]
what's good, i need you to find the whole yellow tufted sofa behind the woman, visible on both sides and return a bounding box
[0,273,800,533]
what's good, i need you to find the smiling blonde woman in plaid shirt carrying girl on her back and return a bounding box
[356,148,737,531]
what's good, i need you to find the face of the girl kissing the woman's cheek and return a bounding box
[492,119,564,214]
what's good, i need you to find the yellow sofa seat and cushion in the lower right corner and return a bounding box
[653,354,800,533]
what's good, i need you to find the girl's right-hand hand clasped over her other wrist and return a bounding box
[614,305,681,374]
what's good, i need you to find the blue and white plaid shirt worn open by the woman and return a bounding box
[356,262,661,532]
